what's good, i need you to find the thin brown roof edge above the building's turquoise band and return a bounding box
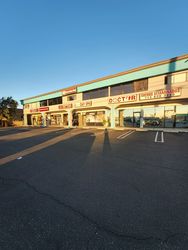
[22,54,188,101]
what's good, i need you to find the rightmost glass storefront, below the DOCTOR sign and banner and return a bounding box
[119,104,188,128]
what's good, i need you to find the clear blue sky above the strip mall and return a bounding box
[0,0,188,106]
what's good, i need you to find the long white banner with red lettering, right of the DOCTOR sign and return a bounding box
[140,88,181,100]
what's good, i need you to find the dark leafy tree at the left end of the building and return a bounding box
[0,96,18,124]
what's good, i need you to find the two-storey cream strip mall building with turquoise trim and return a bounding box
[22,54,188,128]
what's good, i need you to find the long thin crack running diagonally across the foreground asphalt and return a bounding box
[0,176,185,245]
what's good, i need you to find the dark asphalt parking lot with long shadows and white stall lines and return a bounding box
[0,128,188,250]
